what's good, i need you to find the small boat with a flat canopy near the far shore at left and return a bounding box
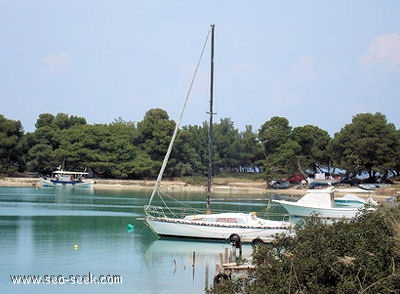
[39,169,94,189]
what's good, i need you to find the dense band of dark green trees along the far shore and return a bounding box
[0,109,400,179]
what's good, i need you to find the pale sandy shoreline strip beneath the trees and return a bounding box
[0,177,399,201]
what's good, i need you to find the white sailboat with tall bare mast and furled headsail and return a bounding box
[144,25,292,242]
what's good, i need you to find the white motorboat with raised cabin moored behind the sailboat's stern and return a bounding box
[272,187,374,219]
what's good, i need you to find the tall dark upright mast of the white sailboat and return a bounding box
[207,25,215,211]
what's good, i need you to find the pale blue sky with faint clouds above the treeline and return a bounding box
[0,0,400,135]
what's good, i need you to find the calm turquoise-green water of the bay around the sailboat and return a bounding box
[0,187,288,294]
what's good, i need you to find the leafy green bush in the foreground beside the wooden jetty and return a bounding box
[208,202,400,294]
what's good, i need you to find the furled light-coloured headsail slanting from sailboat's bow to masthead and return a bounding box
[149,30,210,205]
